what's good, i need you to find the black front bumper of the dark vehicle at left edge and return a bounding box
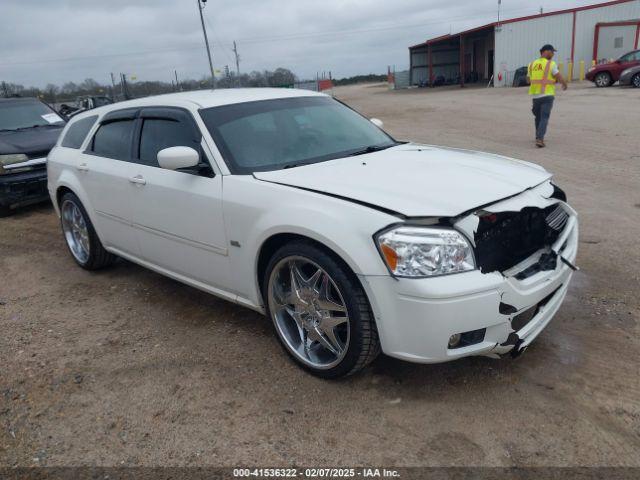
[0,168,49,208]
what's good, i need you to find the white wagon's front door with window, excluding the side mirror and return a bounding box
[126,107,228,290]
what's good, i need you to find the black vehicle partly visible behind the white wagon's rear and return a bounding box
[0,98,65,217]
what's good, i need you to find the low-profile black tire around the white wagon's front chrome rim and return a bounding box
[262,240,381,379]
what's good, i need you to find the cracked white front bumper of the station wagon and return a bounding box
[361,202,578,363]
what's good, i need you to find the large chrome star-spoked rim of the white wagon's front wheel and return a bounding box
[268,257,350,369]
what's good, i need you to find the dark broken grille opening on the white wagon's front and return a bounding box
[475,204,569,273]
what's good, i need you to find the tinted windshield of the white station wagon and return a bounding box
[200,97,397,174]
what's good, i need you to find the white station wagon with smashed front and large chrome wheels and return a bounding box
[48,89,578,378]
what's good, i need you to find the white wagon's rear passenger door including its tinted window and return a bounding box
[81,109,140,257]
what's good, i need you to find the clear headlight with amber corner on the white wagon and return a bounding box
[375,227,476,278]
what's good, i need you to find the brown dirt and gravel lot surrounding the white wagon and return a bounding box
[0,80,640,466]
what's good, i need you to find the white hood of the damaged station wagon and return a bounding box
[254,144,551,217]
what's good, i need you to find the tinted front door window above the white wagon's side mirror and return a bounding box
[140,118,200,167]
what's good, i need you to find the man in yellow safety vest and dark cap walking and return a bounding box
[527,45,567,148]
